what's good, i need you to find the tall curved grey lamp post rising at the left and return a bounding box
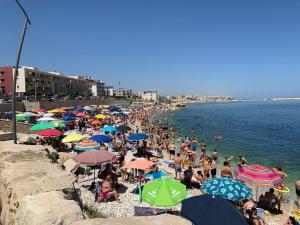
[12,0,31,144]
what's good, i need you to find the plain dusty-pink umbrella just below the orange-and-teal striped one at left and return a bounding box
[73,150,116,165]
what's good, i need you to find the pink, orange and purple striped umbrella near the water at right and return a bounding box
[234,165,283,187]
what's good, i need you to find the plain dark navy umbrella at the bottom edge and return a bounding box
[180,194,248,225]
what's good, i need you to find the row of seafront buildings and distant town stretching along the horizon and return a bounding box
[0,66,300,104]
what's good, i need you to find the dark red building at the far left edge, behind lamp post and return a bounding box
[0,66,13,98]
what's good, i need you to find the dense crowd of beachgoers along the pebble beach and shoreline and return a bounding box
[17,106,300,225]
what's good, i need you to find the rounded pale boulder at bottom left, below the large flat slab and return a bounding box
[15,191,83,225]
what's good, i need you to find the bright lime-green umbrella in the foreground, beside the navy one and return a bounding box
[142,178,187,207]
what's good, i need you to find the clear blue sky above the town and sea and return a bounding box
[0,0,300,97]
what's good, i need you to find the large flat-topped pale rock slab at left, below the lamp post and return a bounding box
[0,141,75,225]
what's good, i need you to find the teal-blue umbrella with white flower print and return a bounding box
[201,177,252,201]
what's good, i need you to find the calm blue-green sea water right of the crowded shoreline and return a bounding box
[168,102,300,193]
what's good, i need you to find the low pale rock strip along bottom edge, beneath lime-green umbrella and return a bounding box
[72,214,192,225]
